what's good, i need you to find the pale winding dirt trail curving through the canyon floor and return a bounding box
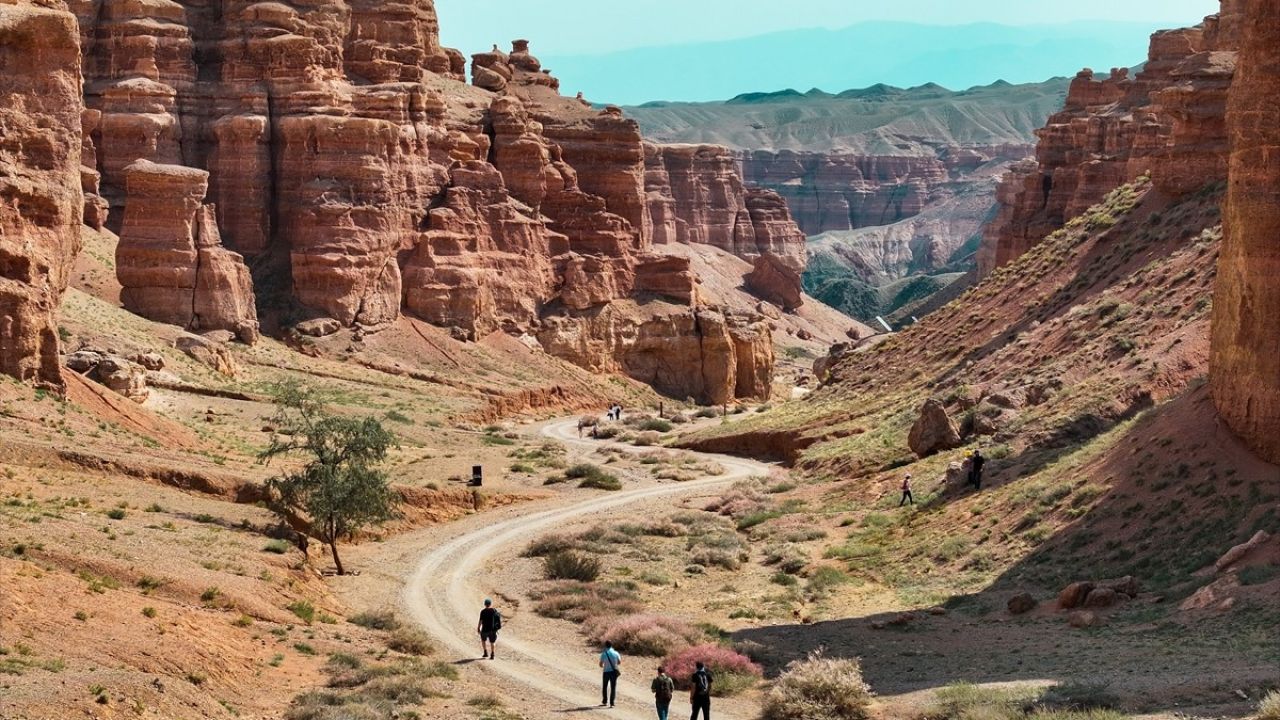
[402,419,769,720]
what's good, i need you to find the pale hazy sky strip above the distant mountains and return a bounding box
[435,0,1219,55]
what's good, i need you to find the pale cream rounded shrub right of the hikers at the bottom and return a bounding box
[763,651,872,720]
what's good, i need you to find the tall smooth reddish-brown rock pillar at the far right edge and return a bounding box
[1211,0,1280,464]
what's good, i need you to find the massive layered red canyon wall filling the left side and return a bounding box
[0,0,804,401]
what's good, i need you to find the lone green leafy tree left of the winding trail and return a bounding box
[259,383,399,575]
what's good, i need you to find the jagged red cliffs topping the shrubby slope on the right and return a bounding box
[978,0,1239,275]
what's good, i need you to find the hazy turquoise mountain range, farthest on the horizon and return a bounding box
[543,22,1160,105]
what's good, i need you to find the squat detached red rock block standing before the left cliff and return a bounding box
[115,160,259,345]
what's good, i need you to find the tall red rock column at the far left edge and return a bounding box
[0,0,84,388]
